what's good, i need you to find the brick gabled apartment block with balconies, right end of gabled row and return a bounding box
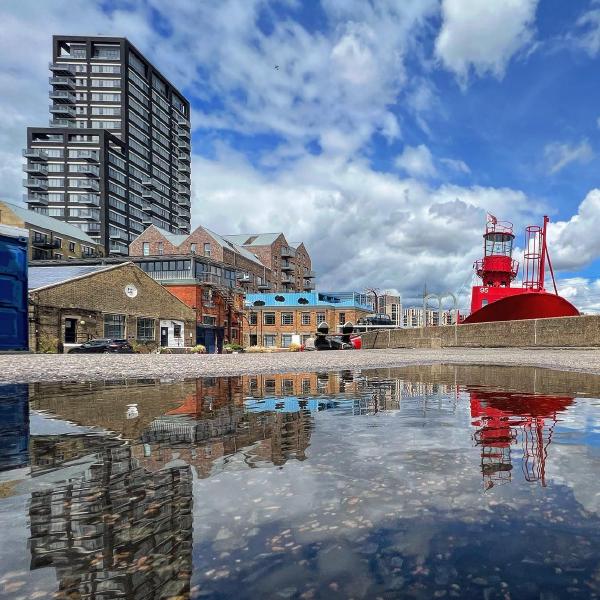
[223,233,316,292]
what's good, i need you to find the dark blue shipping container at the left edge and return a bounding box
[0,225,29,350]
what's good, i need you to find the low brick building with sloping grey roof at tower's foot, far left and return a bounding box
[0,201,103,261]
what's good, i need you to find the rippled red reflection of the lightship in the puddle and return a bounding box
[470,390,573,489]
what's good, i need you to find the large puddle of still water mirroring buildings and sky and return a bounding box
[0,365,600,600]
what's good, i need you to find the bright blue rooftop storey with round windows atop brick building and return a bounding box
[246,292,373,310]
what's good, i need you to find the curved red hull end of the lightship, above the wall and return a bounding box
[463,292,579,324]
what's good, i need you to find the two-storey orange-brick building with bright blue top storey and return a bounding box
[244,292,373,348]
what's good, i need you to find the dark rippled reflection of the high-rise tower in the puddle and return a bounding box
[29,446,192,600]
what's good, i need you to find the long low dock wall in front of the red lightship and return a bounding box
[362,315,600,349]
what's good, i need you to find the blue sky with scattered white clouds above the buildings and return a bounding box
[0,0,600,311]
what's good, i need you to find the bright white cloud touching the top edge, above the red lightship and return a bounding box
[435,0,538,83]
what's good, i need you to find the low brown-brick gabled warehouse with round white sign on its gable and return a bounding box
[29,263,196,351]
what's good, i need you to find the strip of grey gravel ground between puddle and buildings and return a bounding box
[0,348,600,383]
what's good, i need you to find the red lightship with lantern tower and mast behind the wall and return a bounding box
[463,215,579,323]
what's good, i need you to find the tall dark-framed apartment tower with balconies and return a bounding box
[23,35,191,255]
